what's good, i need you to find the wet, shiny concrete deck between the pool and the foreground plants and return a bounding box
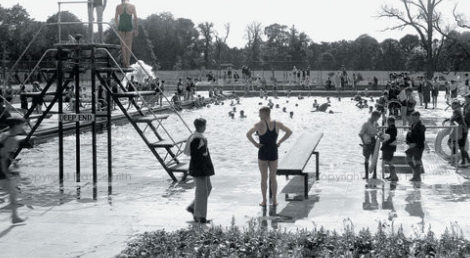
[0,95,470,257]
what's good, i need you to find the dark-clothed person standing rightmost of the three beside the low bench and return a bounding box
[405,111,426,182]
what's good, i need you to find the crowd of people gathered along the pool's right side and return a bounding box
[353,70,470,182]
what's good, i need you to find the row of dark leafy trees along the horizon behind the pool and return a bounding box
[0,0,470,77]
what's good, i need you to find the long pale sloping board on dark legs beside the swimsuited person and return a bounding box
[277,133,323,199]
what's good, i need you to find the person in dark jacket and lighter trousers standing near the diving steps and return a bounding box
[184,118,215,223]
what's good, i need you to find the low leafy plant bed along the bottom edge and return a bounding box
[116,220,470,258]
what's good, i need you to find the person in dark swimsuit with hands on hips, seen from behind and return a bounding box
[246,107,292,207]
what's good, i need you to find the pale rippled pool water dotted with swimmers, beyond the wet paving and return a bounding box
[17,95,369,189]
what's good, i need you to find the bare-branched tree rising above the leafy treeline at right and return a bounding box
[379,0,443,79]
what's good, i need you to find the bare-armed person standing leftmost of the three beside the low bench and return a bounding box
[359,111,381,179]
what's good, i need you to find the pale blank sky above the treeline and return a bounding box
[0,0,470,47]
